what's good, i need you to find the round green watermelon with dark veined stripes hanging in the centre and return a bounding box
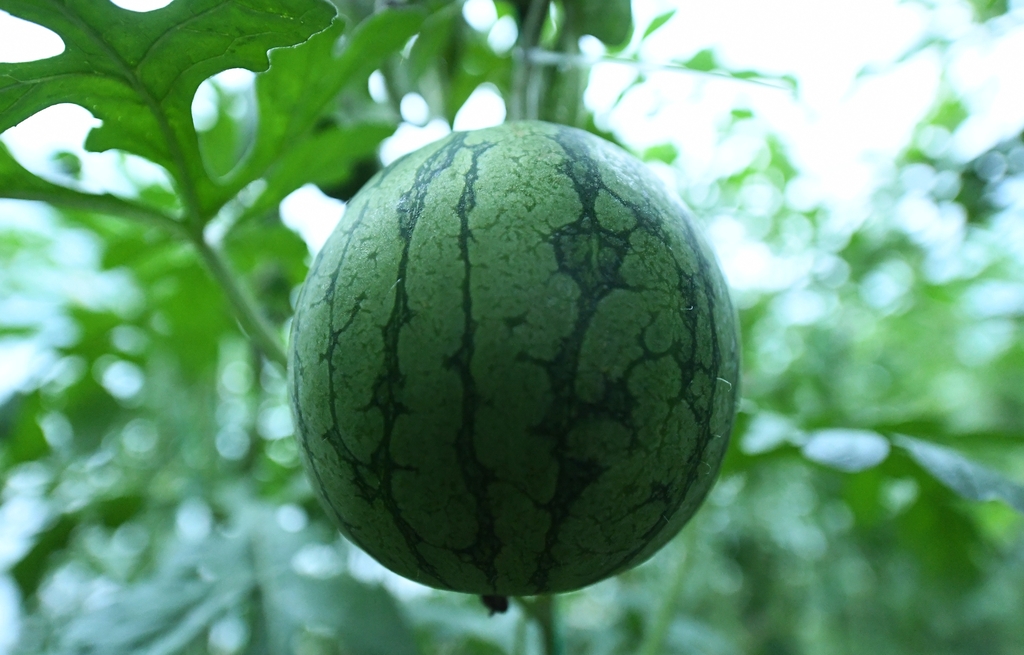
[289,122,738,596]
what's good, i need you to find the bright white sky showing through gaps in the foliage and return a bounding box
[0,0,1024,638]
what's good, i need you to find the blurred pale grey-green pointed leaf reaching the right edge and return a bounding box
[895,435,1024,514]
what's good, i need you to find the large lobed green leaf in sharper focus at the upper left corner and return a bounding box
[0,0,335,219]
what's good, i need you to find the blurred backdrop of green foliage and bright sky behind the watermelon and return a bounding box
[0,0,1024,655]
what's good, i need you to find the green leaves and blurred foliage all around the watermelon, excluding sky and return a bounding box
[0,0,1024,655]
